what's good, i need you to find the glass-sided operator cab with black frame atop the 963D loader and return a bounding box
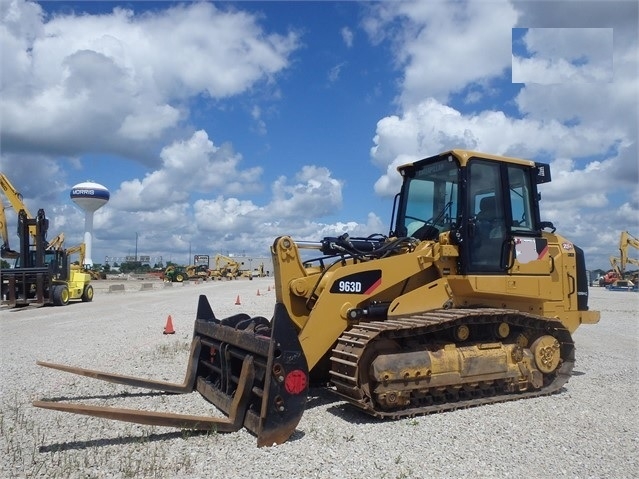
[391,150,552,274]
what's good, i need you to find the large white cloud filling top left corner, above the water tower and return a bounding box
[0,0,298,160]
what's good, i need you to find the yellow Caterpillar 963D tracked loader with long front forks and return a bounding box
[34,150,599,446]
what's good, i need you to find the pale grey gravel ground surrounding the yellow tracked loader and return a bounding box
[0,278,639,479]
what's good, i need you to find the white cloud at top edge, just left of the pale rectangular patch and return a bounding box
[365,0,517,108]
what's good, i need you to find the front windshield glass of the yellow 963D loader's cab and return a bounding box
[397,156,459,239]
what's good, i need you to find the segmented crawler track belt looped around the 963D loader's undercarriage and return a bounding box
[330,308,575,419]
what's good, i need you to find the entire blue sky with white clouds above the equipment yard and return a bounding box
[0,0,639,269]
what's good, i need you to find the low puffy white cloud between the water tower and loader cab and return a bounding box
[104,159,350,252]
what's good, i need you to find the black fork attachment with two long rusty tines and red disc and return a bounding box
[33,295,309,447]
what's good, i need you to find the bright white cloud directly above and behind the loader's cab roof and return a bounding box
[371,98,622,187]
